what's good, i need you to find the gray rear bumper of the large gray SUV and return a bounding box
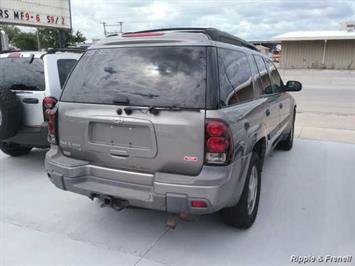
[45,146,250,214]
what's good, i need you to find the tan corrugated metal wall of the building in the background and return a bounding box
[280,40,355,69]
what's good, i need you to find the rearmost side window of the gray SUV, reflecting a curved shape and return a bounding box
[218,49,254,106]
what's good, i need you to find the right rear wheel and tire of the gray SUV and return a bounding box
[221,152,262,229]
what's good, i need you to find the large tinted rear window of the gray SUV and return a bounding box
[61,46,206,108]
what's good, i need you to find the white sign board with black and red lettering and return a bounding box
[0,0,71,29]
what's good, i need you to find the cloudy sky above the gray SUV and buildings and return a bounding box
[71,0,355,41]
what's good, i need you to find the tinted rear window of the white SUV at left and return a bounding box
[0,57,45,91]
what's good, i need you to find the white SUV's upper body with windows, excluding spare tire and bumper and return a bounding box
[0,52,80,127]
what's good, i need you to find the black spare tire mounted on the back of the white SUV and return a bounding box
[0,88,22,140]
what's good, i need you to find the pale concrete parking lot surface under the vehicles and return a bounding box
[0,139,355,265]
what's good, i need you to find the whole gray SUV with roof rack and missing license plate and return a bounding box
[46,28,302,228]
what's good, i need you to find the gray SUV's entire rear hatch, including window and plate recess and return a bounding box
[58,46,207,175]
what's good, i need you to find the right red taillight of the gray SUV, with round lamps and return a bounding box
[205,119,234,165]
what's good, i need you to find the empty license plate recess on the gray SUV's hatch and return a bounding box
[89,122,153,149]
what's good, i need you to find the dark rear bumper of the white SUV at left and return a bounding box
[7,122,49,148]
